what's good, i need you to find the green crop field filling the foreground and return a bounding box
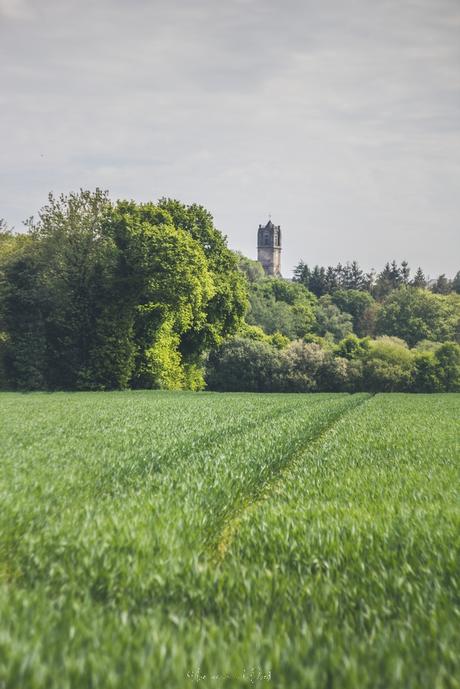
[0,392,460,689]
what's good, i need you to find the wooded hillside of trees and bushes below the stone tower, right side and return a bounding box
[215,255,460,392]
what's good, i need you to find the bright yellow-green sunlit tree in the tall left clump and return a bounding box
[105,201,216,388]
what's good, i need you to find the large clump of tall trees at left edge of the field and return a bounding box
[0,189,246,389]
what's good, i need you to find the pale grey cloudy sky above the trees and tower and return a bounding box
[0,0,460,277]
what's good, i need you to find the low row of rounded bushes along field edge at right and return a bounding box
[206,333,460,392]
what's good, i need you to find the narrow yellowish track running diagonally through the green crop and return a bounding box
[209,393,375,564]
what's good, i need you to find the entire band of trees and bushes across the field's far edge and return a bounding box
[0,189,460,392]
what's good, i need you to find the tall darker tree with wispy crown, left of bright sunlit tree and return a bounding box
[28,189,134,389]
